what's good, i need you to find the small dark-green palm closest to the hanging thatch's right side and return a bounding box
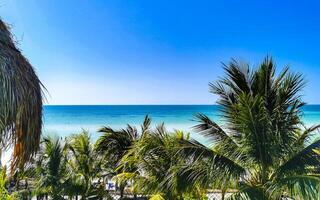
[35,137,68,200]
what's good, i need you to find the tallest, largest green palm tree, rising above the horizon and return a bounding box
[179,58,320,199]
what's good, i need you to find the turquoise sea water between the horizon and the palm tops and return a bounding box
[44,105,320,140]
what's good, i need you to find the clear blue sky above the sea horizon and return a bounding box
[0,0,320,104]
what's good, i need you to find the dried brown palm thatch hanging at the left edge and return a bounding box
[0,19,43,169]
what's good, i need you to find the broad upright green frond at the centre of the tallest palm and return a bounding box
[232,94,278,166]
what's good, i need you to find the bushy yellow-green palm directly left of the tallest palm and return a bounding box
[116,124,208,199]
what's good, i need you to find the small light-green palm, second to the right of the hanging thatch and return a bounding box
[68,131,107,200]
